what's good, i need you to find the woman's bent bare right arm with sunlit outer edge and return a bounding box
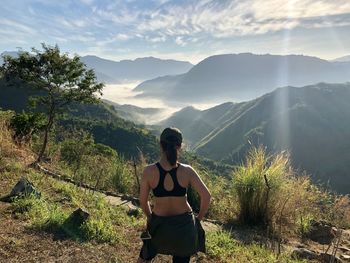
[190,167,211,221]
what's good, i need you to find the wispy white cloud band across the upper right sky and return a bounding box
[127,0,350,39]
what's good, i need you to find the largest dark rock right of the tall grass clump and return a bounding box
[306,221,337,245]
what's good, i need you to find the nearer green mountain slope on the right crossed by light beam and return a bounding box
[161,83,350,193]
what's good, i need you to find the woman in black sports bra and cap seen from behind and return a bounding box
[137,128,211,263]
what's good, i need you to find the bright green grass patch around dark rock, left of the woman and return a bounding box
[8,172,145,244]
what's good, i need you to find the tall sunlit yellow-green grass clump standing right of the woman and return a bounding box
[233,147,321,230]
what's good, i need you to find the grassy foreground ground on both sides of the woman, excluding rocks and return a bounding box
[0,114,304,262]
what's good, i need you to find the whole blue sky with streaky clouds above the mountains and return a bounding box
[0,0,350,63]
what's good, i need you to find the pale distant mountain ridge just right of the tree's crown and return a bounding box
[81,56,193,83]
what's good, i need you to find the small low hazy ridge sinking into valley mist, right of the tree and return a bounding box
[103,100,166,124]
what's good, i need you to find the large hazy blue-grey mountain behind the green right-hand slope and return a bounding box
[135,53,350,103]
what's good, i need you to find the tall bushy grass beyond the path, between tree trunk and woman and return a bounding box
[60,134,137,194]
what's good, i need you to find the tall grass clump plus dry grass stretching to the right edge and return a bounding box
[233,147,350,236]
